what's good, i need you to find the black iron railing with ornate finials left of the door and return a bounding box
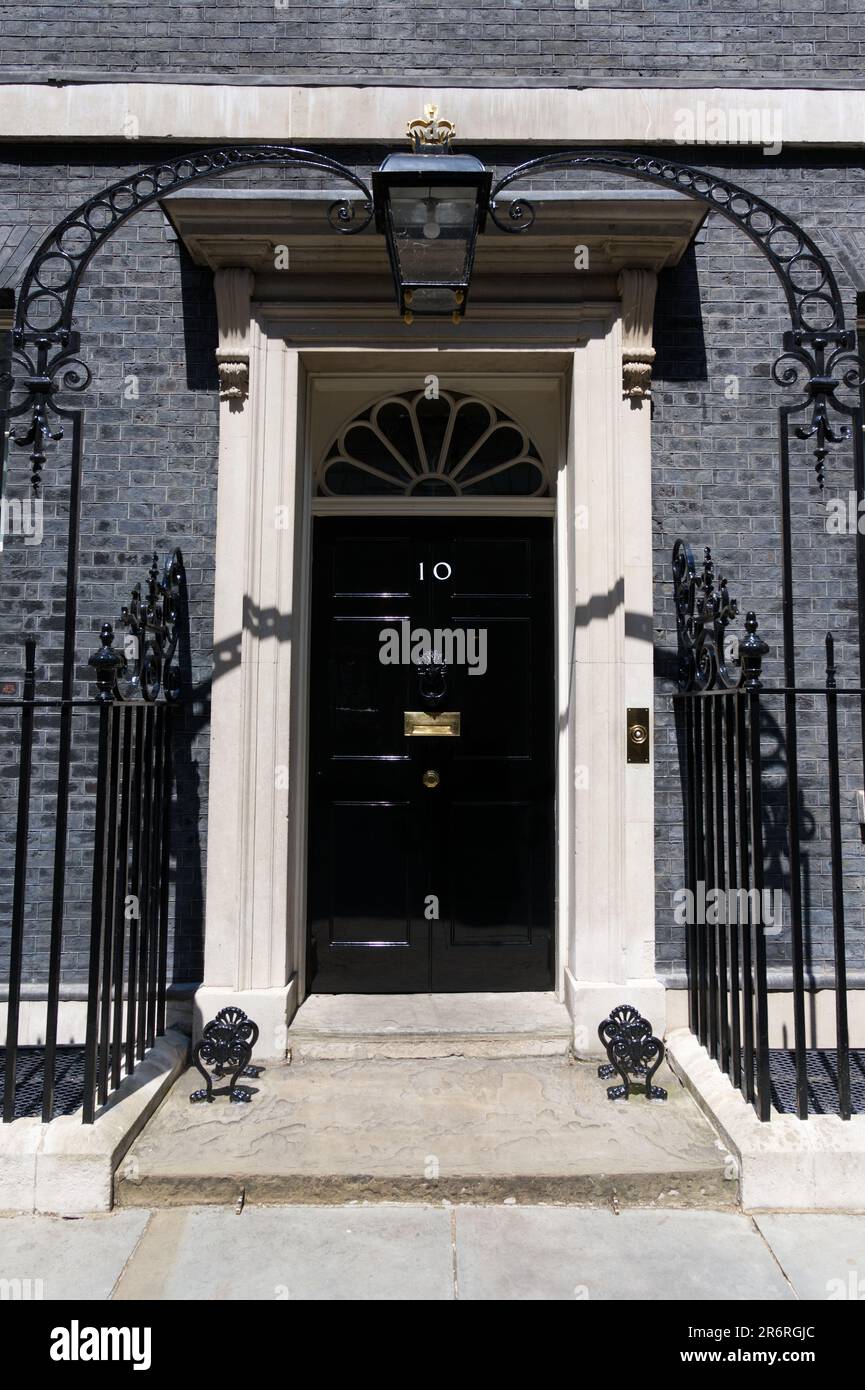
[0,550,185,1123]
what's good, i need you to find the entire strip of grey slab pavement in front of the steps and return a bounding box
[0,1202,865,1302]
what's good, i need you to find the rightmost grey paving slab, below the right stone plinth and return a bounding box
[754,1212,865,1302]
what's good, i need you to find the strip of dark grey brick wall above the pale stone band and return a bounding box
[0,0,865,85]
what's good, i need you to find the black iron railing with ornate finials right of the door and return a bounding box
[673,541,864,1120]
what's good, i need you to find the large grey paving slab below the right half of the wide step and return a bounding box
[456,1207,795,1301]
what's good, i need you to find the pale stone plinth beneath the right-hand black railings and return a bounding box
[666,1029,865,1212]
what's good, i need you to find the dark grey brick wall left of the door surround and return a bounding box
[0,146,218,981]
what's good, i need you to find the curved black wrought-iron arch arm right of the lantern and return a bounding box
[490,150,864,488]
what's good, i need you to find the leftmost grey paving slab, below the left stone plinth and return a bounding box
[0,1211,150,1300]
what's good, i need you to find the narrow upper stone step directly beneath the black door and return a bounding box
[288,992,573,1061]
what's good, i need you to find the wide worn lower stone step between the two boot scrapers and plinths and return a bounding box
[115,1058,737,1207]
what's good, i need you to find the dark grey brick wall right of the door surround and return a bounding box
[652,154,865,980]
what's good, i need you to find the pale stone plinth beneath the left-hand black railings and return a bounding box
[0,1029,189,1216]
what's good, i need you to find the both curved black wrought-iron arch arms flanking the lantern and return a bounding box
[8,145,861,491]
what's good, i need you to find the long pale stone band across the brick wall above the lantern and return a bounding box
[0,81,865,148]
